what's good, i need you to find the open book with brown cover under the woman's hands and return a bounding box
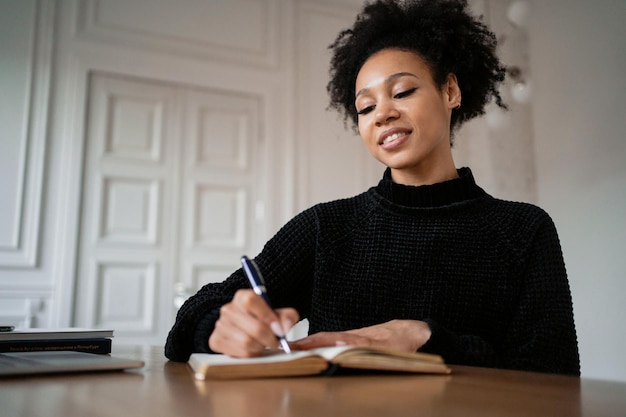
[189,346,450,379]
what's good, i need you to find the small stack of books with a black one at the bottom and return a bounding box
[0,327,113,354]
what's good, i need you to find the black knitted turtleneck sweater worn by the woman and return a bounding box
[165,168,580,375]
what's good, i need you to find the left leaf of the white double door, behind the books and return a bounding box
[74,73,180,341]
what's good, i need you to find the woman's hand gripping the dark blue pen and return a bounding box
[209,289,299,358]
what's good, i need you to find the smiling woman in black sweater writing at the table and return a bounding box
[166,0,580,375]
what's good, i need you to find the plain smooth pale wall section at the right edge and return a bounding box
[529,0,626,381]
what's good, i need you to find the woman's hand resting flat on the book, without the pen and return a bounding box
[289,320,431,352]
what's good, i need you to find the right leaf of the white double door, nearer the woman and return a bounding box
[179,90,266,293]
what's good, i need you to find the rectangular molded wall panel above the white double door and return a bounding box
[75,0,280,69]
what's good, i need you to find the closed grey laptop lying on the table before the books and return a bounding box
[0,351,144,377]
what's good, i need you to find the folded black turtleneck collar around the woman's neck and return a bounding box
[376,168,487,208]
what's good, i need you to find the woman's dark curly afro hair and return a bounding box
[326,0,506,141]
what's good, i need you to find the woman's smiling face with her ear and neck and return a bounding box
[355,49,461,185]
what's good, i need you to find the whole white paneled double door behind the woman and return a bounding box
[74,73,267,344]
